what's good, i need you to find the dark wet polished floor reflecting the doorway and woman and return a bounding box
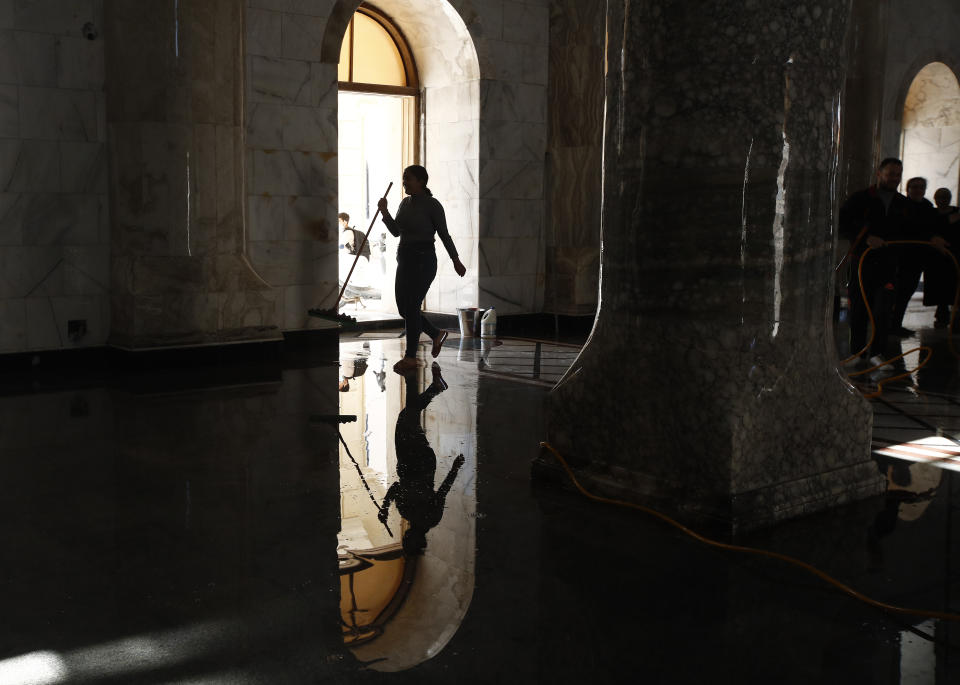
[0,330,960,685]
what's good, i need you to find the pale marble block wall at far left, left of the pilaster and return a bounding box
[0,0,110,353]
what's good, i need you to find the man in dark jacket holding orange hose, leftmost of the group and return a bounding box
[840,157,910,368]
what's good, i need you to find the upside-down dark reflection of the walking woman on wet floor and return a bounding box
[379,362,464,555]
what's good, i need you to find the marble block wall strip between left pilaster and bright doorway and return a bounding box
[246,0,339,330]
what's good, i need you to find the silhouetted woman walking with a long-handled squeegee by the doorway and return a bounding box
[378,165,467,373]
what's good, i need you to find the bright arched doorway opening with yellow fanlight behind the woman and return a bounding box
[337,5,420,318]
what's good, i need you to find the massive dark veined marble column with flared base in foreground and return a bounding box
[549,0,881,528]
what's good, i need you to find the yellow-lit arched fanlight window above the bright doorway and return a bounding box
[337,5,419,95]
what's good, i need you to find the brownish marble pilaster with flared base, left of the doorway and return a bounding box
[104,0,279,348]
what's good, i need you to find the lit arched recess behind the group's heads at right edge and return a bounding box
[901,62,960,199]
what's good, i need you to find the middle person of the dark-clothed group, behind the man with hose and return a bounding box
[890,176,939,337]
